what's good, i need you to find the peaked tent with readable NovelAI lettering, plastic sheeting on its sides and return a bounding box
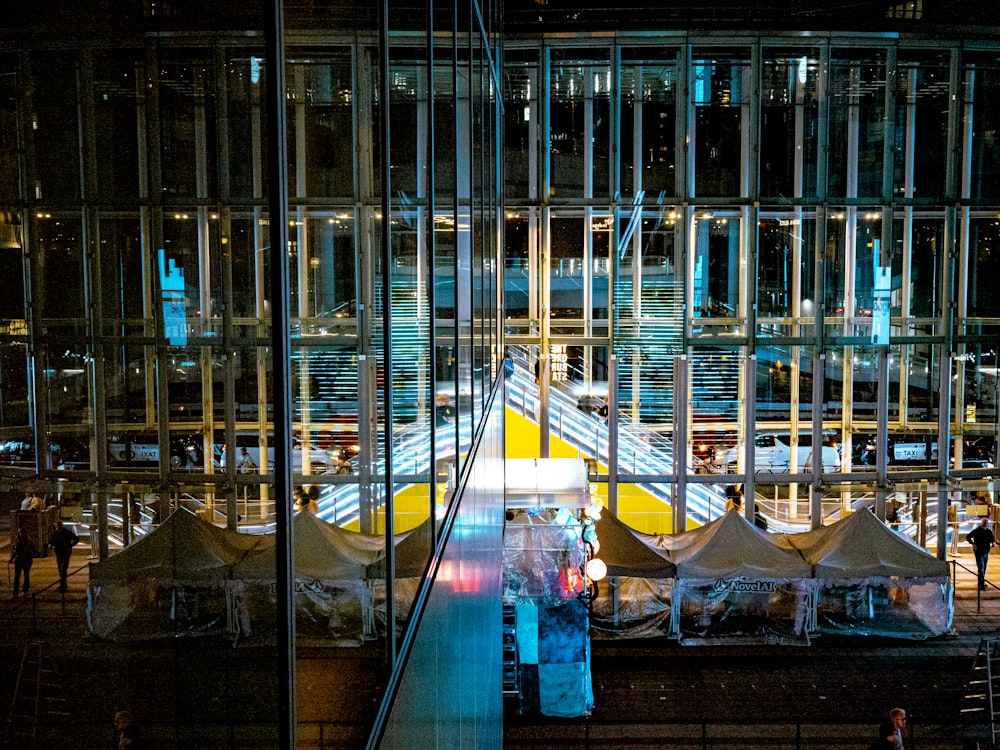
[658,510,812,644]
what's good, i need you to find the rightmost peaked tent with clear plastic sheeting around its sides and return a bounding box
[779,510,954,639]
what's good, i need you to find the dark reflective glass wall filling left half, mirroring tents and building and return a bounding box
[0,0,503,747]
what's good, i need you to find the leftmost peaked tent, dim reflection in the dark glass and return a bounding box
[87,509,261,640]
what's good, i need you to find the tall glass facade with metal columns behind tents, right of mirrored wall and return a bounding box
[504,30,1000,531]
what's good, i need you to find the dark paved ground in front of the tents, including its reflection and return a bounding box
[0,524,1000,750]
